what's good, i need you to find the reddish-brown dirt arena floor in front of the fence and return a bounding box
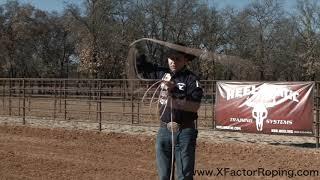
[0,124,320,180]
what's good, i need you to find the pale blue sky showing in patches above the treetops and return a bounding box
[0,0,295,12]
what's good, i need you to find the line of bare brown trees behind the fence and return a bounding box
[0,0,320,80]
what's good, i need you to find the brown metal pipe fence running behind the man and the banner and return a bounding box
[0,78,320,147]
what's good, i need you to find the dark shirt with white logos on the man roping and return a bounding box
[140,59,203,124]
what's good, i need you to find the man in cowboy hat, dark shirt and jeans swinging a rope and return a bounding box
[140,44,203,180]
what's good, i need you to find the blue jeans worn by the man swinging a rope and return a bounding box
[156,127,198,180]
